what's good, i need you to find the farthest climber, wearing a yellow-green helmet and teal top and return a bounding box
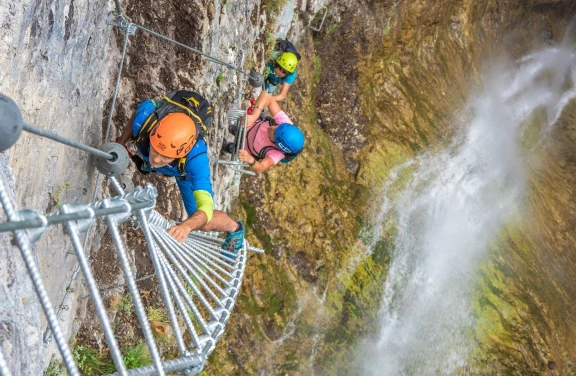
[263,40,300,102]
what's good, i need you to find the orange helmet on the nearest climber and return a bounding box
[150,112,196,158]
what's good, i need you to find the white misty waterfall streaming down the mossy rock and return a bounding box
[359,34,576,376]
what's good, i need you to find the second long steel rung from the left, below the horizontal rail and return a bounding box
[62,205,126,376]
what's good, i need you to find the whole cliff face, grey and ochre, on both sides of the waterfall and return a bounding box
[0,0,576,375]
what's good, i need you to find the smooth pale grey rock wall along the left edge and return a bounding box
[0,0,115,375]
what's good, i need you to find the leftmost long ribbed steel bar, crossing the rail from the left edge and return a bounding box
[0,179,80,376]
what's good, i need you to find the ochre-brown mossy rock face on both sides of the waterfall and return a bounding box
[209,1,576,374]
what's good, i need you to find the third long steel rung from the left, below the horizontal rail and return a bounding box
[103,199,165,375]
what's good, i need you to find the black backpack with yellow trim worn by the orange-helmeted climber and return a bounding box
[134,90,213,173]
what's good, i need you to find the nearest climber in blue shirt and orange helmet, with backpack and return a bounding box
[116,90,244,253]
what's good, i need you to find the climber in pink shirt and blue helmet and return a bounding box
[223,91,304,174]
